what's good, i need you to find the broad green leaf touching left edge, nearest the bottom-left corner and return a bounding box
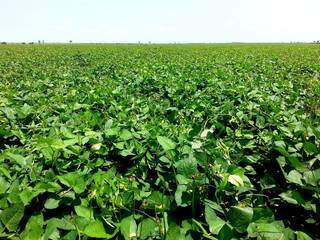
[0,204,24,232]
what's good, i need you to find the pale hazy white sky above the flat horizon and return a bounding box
[0,0,320,42]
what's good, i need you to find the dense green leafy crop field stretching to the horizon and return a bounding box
[0,44,320,240]
